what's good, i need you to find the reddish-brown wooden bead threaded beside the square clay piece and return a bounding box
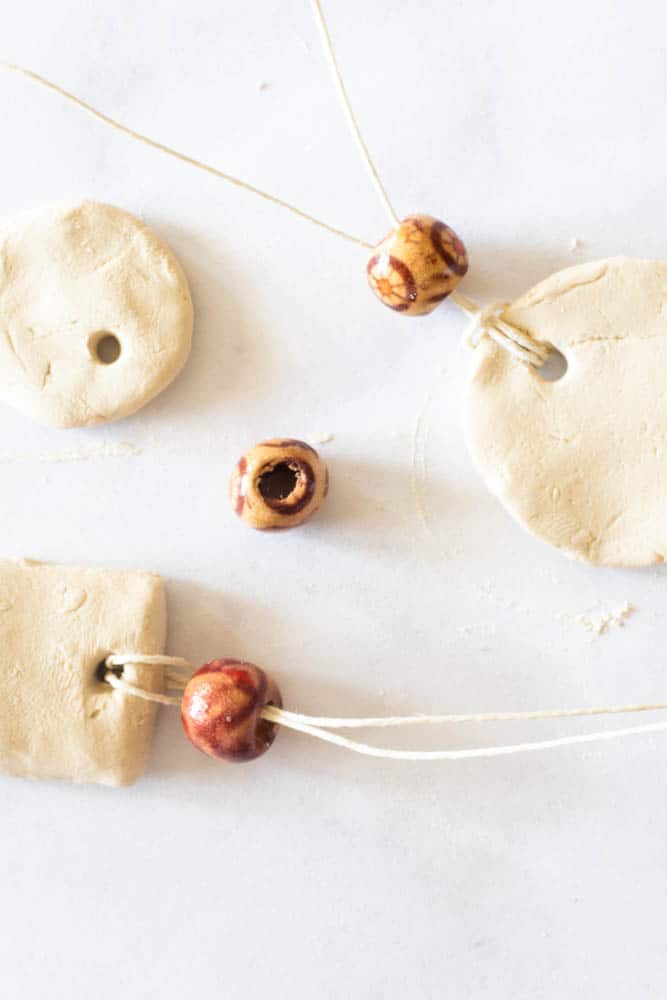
[181,660,282,762]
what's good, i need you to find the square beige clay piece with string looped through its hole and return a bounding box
[0,561,166,785]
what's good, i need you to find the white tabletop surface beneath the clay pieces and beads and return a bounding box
[0,0,667,1000]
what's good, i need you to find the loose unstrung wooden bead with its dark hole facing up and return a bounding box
[230,438,329,530]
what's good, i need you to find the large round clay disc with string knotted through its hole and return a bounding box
[467,257,667,566]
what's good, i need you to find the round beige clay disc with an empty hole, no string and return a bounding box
[0,202,192,427]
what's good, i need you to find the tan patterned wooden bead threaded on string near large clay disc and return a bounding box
[366,215,468,316]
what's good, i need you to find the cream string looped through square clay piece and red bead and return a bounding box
[105,653,667,761]
